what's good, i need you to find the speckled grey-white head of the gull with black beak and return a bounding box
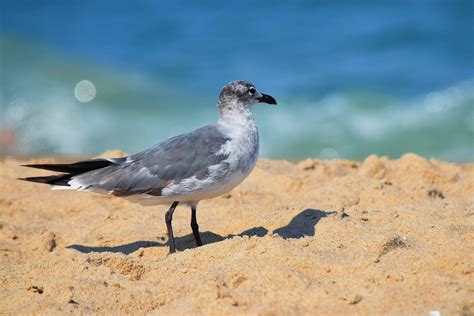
[218,80,277,109]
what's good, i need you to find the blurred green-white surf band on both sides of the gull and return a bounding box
[0,38,474,161]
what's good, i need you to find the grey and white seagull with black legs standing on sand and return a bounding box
[20,80,277,253]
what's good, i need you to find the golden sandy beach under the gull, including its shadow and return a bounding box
[0,154,474,315]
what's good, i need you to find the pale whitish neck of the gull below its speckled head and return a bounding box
[218,106,258,137]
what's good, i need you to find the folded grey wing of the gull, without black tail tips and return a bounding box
[73,125,230,196]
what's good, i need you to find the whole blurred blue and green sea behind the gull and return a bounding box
[0,0,474,162]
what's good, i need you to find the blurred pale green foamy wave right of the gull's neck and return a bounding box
[258,80,474,161]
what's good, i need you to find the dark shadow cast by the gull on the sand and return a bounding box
[66,208,335,255]
